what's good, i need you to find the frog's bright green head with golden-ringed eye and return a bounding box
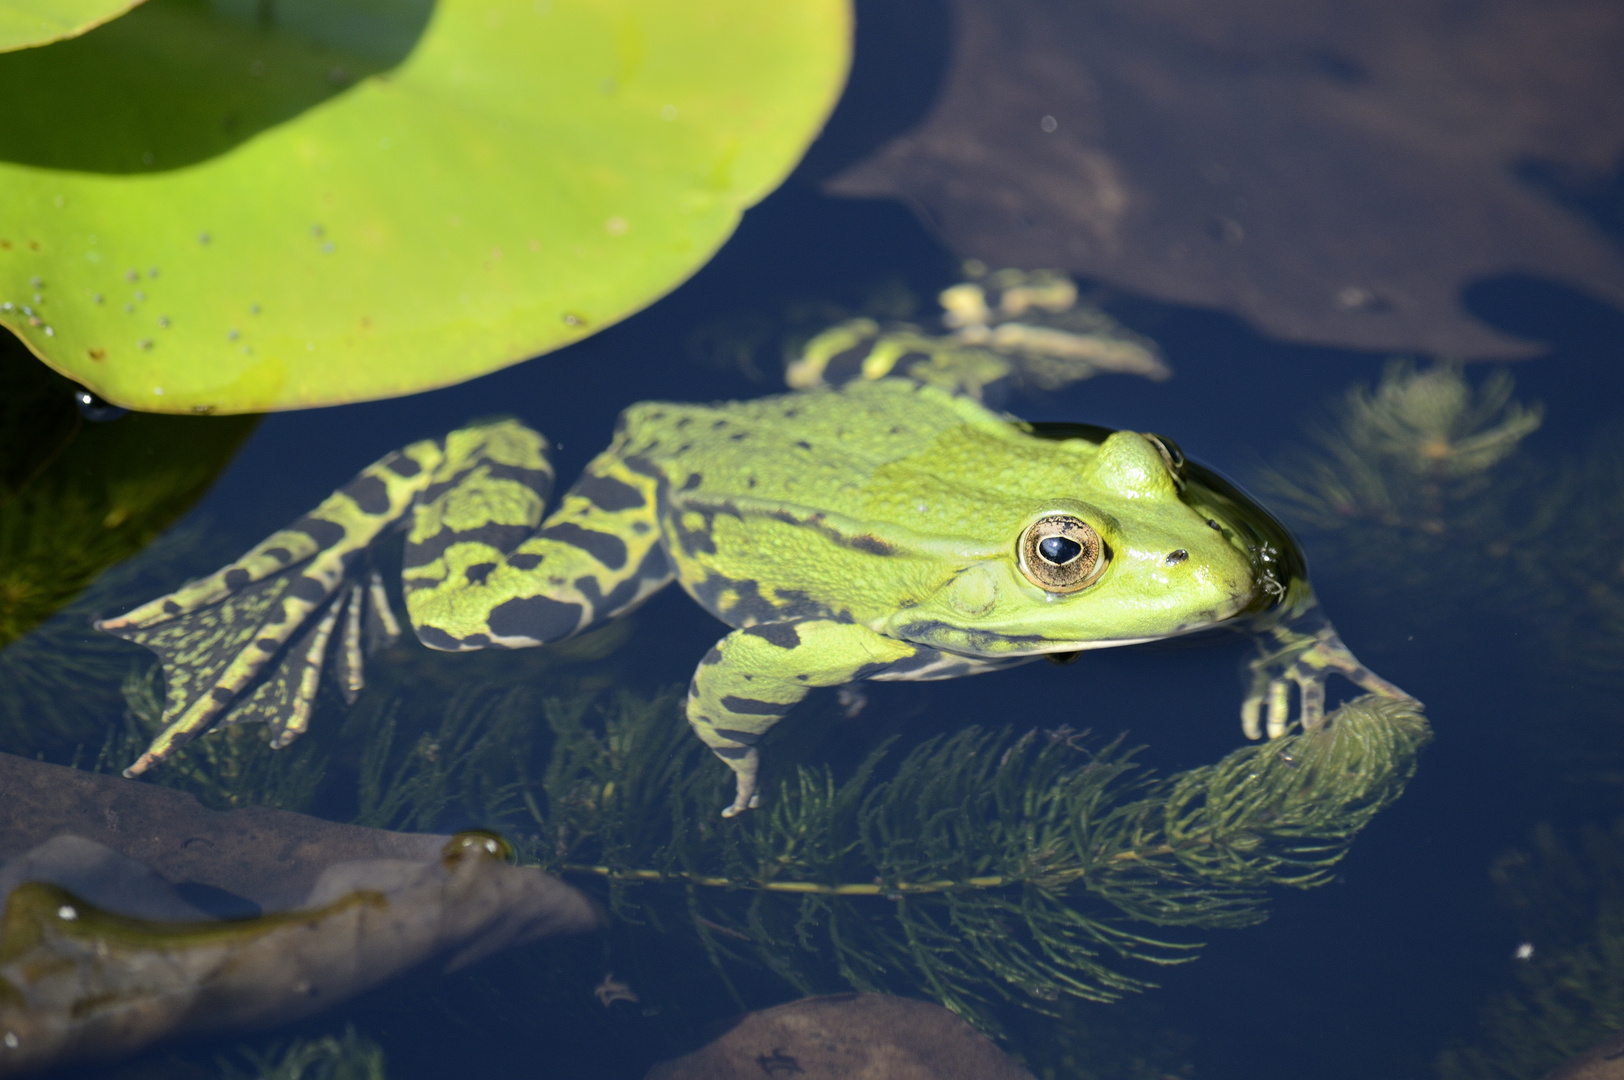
[895,432,1268,654]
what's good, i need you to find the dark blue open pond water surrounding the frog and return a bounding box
[0,2,1624,1080]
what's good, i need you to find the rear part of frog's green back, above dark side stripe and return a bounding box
[620,380,1010,512]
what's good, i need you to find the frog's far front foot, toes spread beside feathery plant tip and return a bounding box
[1241,598,1415,739]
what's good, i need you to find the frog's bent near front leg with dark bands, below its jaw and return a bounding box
[689,619,934,817]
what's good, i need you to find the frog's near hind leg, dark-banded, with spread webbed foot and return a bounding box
[97,421,669,776]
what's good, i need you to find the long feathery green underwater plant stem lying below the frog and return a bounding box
[342,678,1429,1030]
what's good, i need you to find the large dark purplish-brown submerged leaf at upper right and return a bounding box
[830,0,1624,359]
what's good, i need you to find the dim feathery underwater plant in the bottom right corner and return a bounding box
[1437,822,1624,1080]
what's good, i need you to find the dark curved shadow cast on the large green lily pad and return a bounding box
[0,0,434,174]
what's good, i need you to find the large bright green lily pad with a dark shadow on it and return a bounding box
[0,0,851,413]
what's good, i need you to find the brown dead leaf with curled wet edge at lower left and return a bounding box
[0,755,603,1075]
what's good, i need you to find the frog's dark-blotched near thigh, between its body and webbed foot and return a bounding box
[403,453,671,650]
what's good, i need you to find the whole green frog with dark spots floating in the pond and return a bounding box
[99,378,1400,814]
